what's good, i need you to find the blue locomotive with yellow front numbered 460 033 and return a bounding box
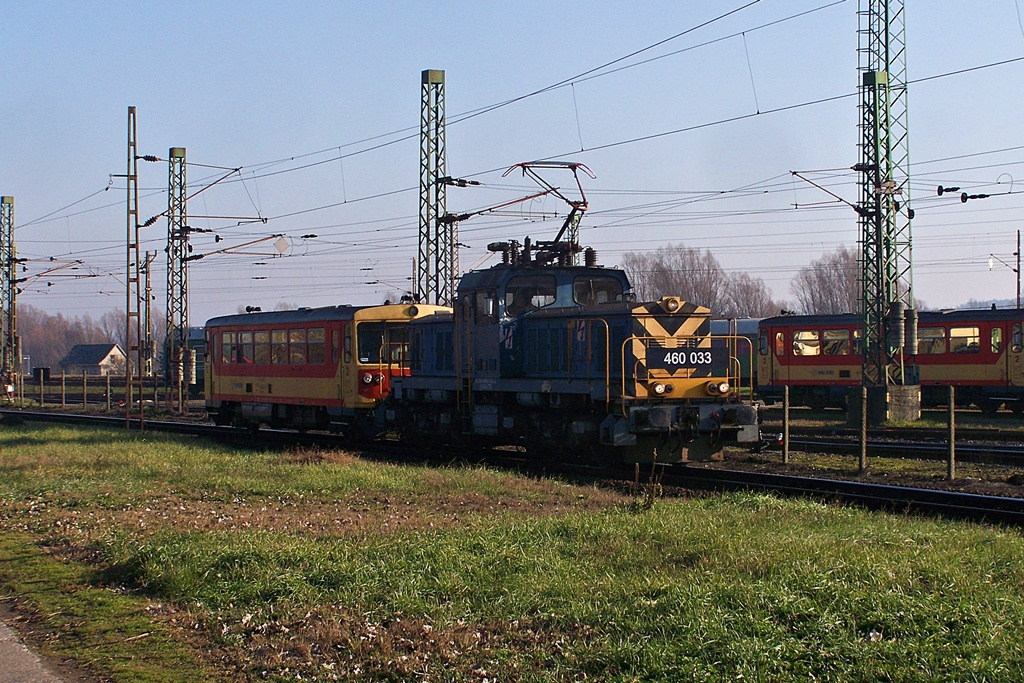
[384,238,760,463]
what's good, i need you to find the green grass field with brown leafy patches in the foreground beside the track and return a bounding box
[0,425,1024,682]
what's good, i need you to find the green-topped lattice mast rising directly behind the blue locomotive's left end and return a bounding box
[416,69,459,306]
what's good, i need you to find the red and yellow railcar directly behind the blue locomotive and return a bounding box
[205,304,451,435]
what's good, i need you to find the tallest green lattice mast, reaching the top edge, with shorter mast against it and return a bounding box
[854,0,915,386]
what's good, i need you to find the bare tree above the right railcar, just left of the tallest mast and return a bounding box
[792,246,860,313]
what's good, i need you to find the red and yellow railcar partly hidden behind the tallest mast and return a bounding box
[757,308,1024,414]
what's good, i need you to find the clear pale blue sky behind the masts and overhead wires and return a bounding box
[0,0,1024,325]
